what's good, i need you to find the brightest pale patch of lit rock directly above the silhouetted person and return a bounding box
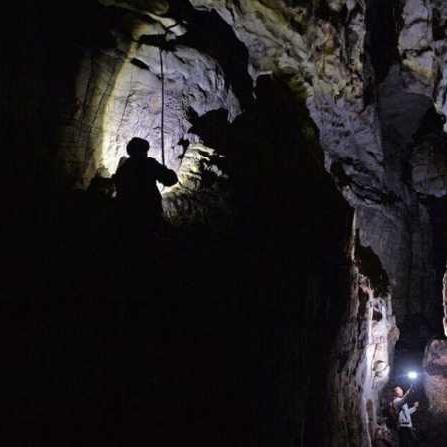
[100,46,240,176]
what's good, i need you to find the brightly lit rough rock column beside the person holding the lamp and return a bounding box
[329,224,399,447]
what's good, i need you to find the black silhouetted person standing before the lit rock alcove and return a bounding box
[113,137,178,230]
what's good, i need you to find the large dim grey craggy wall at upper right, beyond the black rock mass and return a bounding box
[181,0,445,332]
